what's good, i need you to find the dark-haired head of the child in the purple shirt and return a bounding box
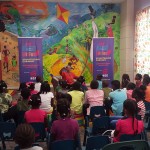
[57,98,70,118]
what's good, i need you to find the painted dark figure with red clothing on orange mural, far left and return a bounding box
[2,45,10,72]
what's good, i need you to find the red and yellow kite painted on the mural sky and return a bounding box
[56,4,70,24]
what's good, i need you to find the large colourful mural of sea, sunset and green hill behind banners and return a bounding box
[0,1,120,83]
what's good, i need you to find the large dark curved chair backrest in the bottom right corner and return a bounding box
[102,140,150,150]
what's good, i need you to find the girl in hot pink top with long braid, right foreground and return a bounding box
[113,99,144,142]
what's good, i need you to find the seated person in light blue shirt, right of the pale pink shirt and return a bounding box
[109,80,127,116]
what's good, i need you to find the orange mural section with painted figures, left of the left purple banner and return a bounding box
[0,31,19,88]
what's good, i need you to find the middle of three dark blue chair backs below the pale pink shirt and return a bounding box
[92,116,109,135]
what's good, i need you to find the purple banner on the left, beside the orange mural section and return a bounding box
[18,37,43,82]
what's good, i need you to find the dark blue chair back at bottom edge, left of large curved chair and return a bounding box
[86,135,110,150]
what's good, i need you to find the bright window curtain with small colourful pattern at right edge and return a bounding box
[135,7,150,74]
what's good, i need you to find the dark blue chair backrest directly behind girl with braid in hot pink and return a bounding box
[120,134,142,142]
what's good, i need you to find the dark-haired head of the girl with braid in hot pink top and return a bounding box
[123,99,138,117]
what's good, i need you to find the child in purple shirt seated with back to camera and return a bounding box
[50,98,80,147]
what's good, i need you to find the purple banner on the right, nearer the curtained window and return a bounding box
[93,38,114,82]
